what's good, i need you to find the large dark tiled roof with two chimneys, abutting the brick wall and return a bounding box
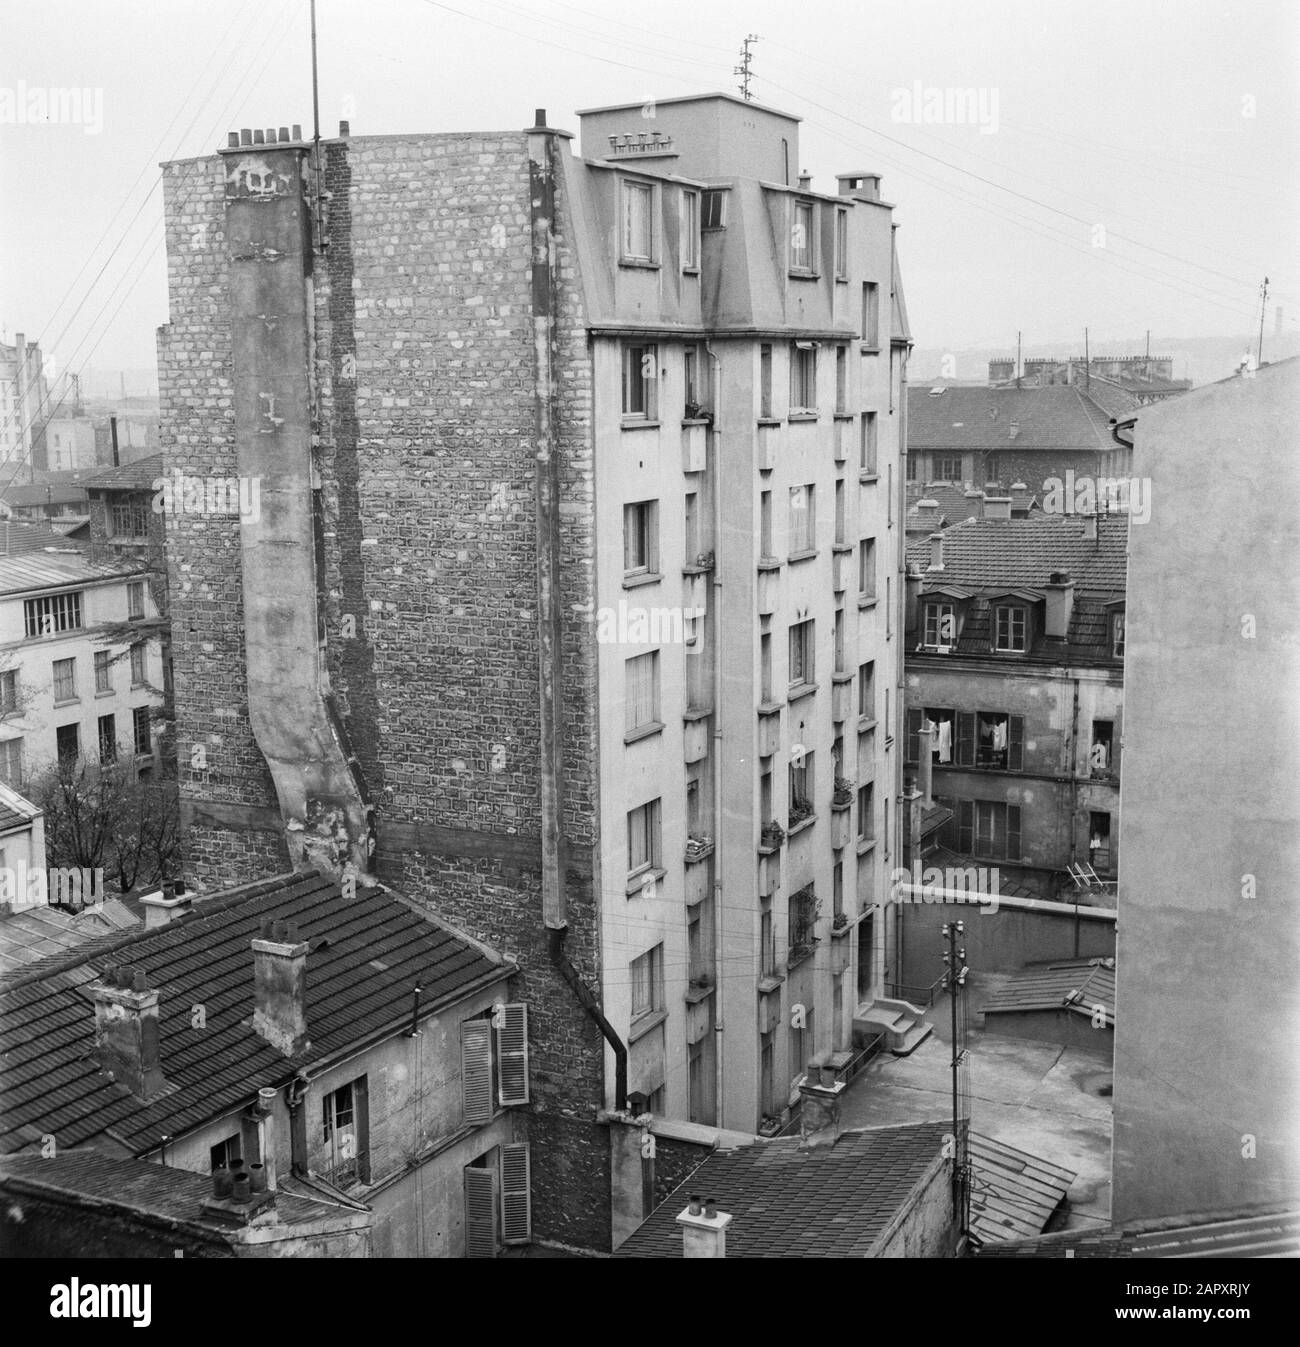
[0,874,515,1153]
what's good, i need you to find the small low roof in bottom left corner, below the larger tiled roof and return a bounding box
[0,1150,356,1235]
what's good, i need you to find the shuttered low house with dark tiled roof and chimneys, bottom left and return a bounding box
[0,874,533,1258]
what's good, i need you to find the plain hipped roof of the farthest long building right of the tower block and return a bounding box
[908,383,1115,451]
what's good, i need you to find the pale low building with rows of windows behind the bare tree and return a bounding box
[0,546,163,789]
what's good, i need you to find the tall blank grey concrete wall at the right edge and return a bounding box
[1113,360,1300,1222]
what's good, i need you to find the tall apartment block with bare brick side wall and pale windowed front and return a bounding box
[160,96,908,1246]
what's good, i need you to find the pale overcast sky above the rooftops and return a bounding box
[0,0,1300,392]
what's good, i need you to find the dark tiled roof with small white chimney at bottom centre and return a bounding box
[614,1122,951,1258]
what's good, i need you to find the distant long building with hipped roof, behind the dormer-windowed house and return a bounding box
[907,383,1137,497]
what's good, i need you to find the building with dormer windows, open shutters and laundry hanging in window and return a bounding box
[905,514,1140,907]
